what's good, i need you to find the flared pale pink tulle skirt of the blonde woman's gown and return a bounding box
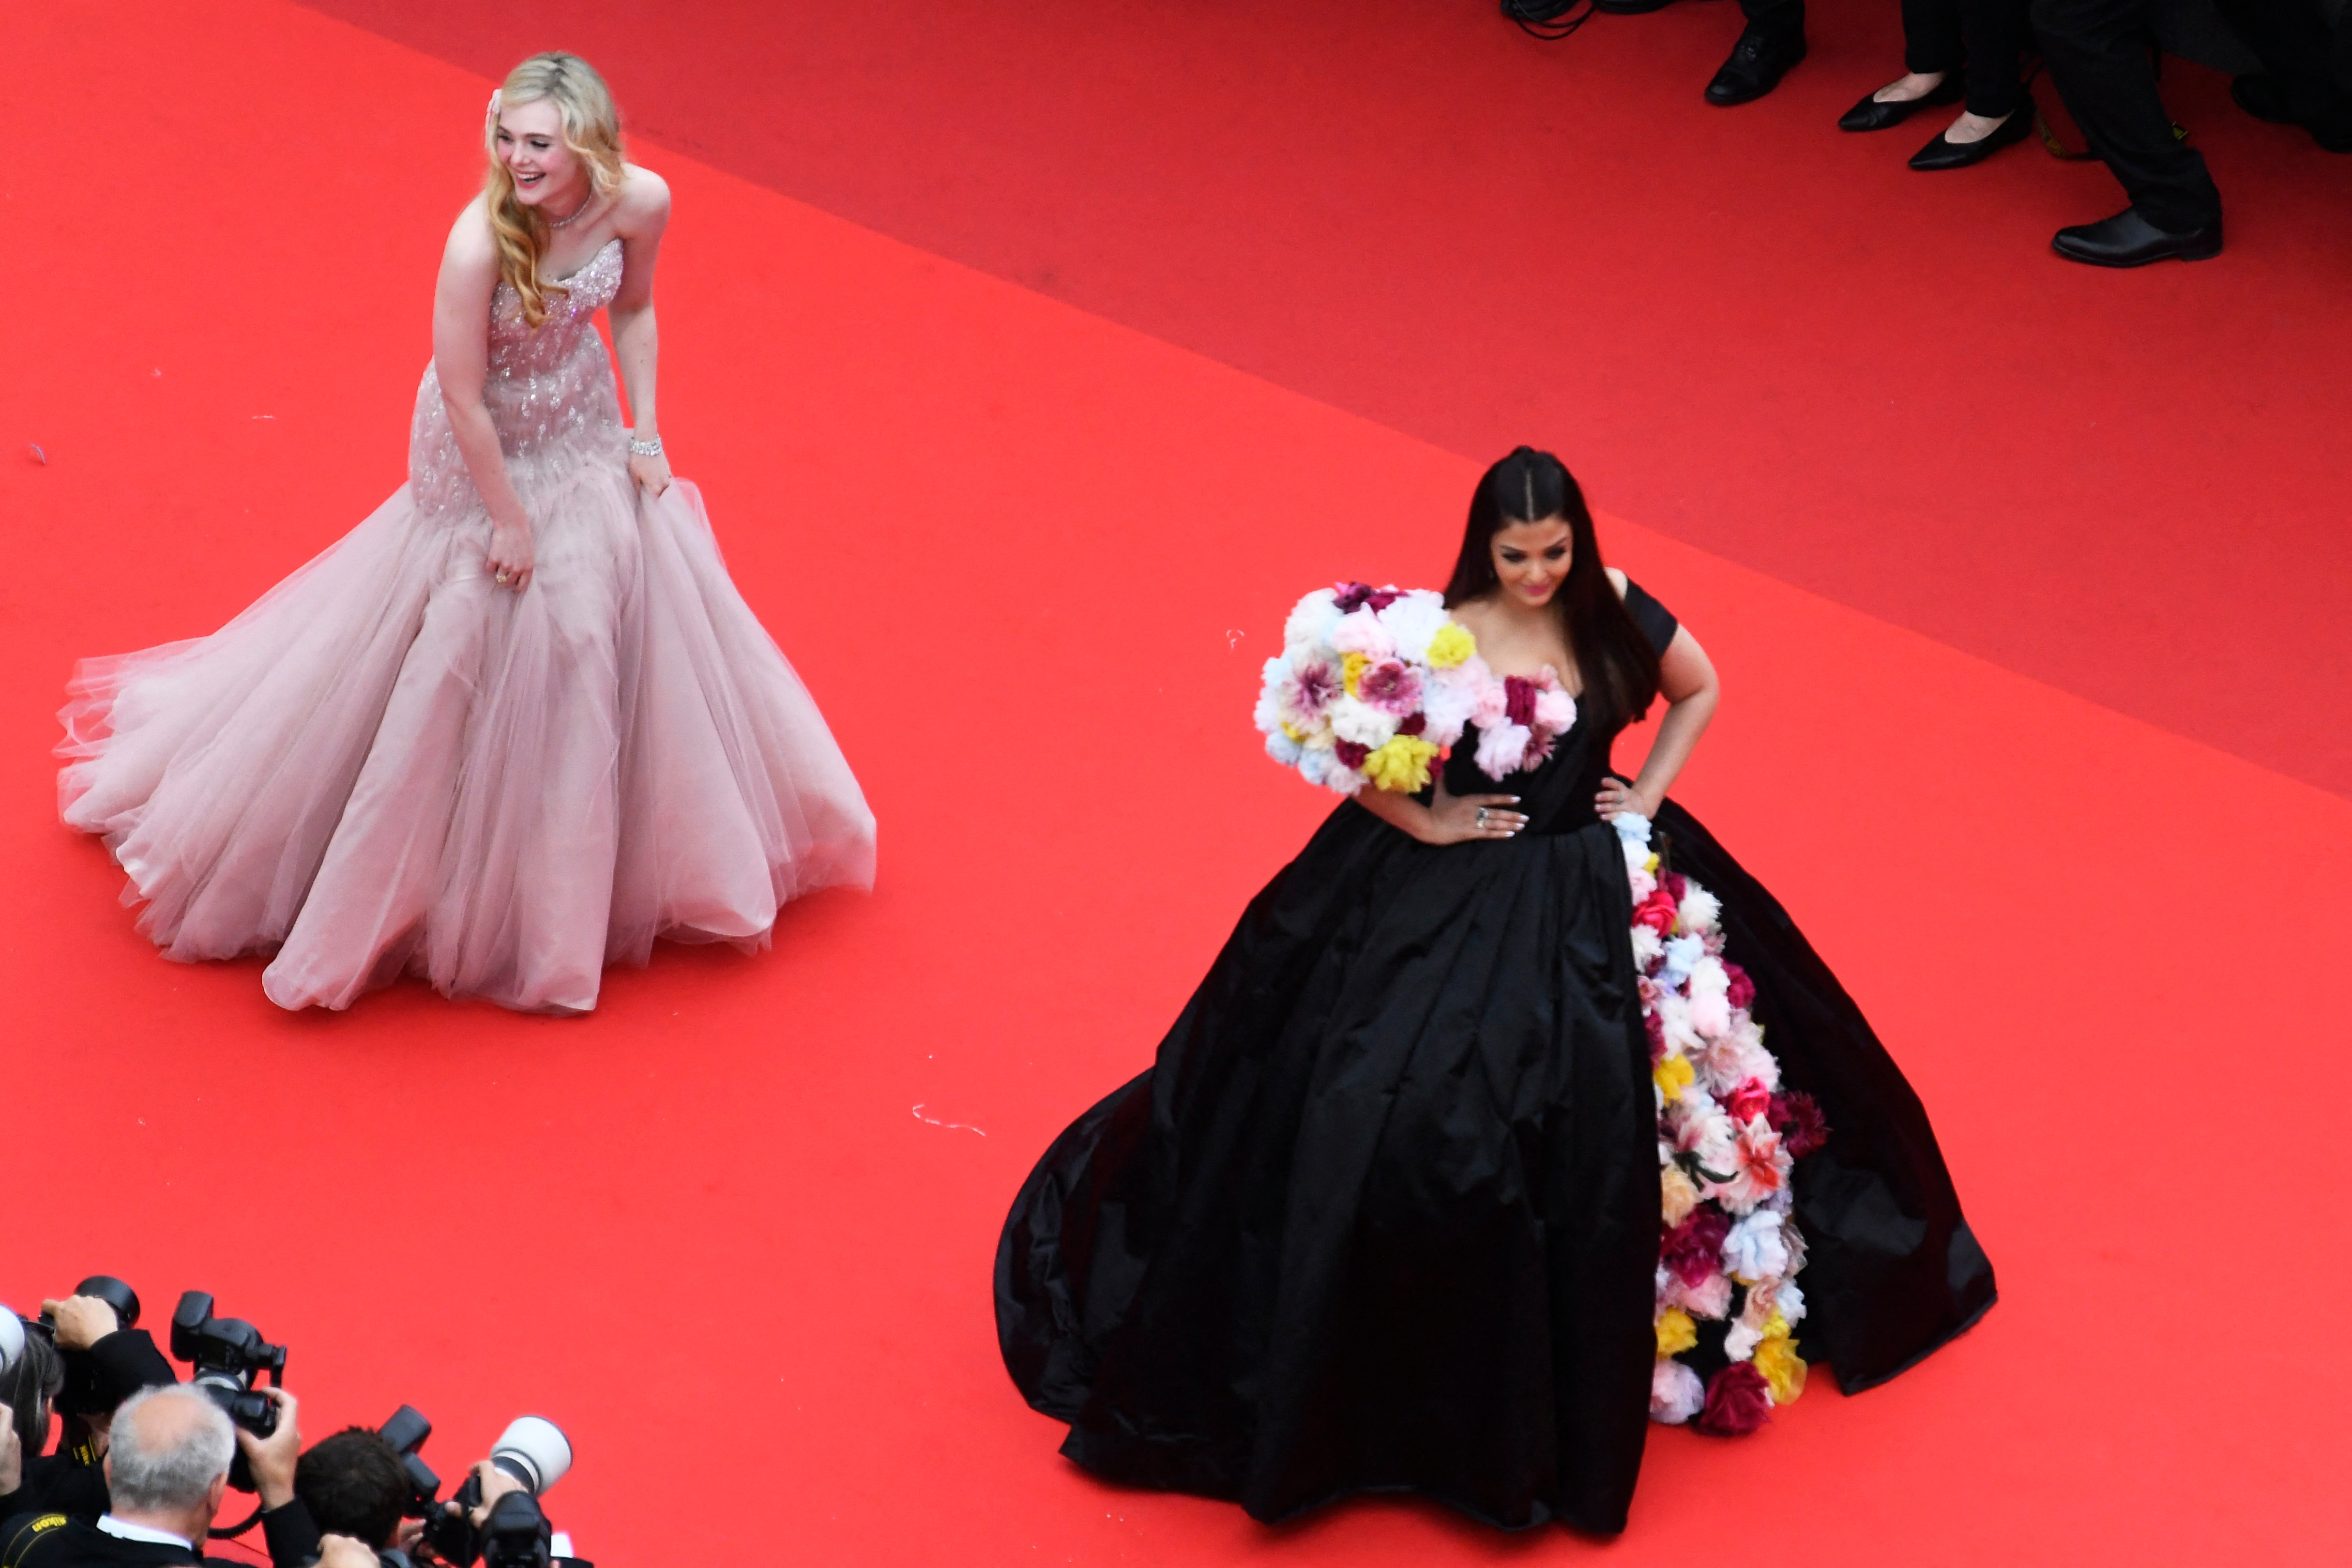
[59,466,875,1011]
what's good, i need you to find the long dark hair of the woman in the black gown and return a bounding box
[1446,447,1658,731]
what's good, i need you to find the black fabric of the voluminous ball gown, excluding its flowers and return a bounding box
[995,576,1994,1533]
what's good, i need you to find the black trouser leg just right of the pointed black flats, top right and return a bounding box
[2032,0,2220,233]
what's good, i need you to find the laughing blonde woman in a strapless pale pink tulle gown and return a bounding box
[59,54,875,1013]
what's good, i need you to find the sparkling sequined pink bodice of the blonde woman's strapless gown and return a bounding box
[409,240,628,522]
